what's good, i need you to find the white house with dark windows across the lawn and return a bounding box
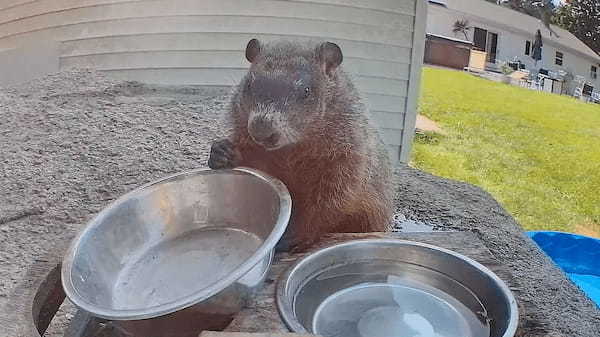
[427,0,600,91]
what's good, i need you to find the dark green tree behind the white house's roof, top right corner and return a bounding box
[553,0,600,53]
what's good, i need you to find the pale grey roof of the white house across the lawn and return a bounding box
[434,0,600,63]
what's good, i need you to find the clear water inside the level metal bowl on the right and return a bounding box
[298,262,490,337]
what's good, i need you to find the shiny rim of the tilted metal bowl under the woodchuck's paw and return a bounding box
[61,167,292,320]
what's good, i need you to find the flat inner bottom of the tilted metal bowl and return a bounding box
[112,226,262,310]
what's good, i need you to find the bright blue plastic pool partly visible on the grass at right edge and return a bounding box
[527,232,600,307]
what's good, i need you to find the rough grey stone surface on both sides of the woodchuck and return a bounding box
[0,70,600,337]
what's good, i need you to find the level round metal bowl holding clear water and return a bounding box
[277,239,518,337]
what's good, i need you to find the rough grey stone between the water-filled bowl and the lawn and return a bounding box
[396,167,600,337]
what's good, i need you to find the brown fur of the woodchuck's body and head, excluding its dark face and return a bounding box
[209,41,392,249]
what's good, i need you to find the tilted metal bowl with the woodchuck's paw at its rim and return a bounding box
[62,168,291,336]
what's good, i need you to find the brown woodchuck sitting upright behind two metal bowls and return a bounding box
[208,39,393,251]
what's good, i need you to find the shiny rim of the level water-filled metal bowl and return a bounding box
[275,238,519,337]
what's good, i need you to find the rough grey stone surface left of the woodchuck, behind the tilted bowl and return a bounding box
[0,71,228,336]
